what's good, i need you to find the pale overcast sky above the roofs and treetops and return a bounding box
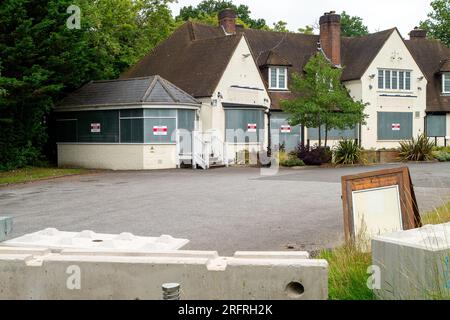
[170,0,431,38]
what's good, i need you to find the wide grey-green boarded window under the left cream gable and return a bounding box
[225,109,264,143]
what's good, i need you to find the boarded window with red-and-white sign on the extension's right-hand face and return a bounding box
[144,118,176,143]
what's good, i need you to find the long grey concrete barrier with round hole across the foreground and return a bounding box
[0,248,328,300]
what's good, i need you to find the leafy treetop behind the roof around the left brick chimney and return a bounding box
[176,0,267,29]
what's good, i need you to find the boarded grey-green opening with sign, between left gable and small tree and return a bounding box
[270,112,301,152]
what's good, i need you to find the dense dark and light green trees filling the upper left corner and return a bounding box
[0,0,173,170]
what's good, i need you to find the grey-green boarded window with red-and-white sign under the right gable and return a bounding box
[377,112,413,140]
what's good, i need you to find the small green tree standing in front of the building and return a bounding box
[281,53,366,146]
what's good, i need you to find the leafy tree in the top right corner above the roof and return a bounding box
[420,0,450,47]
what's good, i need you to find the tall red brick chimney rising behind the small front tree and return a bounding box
[319,11,341,66]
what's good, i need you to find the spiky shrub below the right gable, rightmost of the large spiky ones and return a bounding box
[400,134,434,161]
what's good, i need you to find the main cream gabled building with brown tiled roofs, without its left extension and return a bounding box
[57,10,450,168]
